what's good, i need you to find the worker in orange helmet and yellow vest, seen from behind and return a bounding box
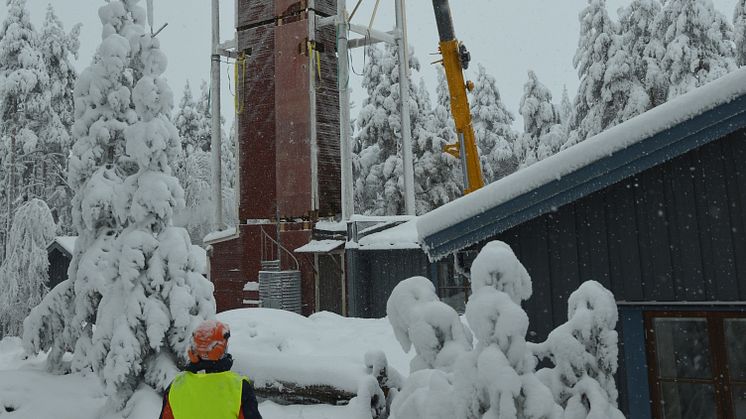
[161,320,262,419]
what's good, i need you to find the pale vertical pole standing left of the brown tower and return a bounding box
[210,0,224,230]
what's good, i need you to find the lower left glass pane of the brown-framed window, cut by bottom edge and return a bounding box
[661,383,717,419]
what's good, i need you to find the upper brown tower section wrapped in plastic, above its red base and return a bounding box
[237,0,341,220]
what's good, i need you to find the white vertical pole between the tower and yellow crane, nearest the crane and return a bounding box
[395,0,416,215]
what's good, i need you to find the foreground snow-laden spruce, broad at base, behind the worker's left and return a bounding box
[90,23,215,409]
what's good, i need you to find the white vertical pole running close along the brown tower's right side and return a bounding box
[337,1,355,221]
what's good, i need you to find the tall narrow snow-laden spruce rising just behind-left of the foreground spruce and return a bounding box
[64,1,147,370]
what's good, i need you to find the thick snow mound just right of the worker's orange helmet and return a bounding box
[224,309,411,393]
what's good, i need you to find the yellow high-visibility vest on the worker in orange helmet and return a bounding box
[168,371,245,419]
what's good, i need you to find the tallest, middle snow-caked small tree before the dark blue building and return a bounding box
[454,241,562,419]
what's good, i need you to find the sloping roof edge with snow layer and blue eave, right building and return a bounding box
[417,69,746,258]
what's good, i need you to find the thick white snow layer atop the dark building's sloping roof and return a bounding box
[417,69,746,252]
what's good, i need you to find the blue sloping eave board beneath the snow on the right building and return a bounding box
[421,96,746,260]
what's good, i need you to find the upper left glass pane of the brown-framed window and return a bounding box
[653,318,712,379]
